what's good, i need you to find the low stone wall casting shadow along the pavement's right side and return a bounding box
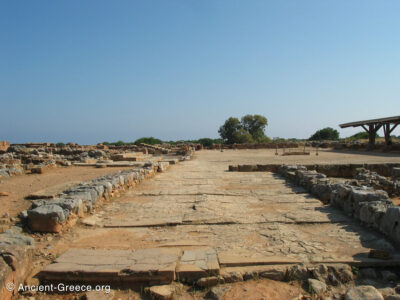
[278,165,400,247]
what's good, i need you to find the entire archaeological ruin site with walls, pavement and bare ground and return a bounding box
[0,142,400,299]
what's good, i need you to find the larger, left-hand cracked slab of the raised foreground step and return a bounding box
[39,248,180,284]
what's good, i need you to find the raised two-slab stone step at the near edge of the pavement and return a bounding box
[38,247,219,286]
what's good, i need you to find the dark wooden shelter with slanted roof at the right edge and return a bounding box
[339,116,400,145]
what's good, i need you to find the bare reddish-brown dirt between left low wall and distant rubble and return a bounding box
[0,166,134,217]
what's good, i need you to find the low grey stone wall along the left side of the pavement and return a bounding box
[24,160,175,232]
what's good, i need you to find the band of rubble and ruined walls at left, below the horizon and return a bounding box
[0,143,189,178]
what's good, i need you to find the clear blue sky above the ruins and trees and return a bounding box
[0,0,400,144]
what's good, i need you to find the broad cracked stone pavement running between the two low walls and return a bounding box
[42,151,400,282]
